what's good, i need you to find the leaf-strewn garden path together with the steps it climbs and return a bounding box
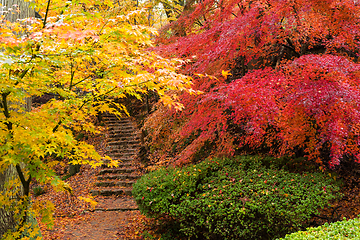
[39,115,145,240]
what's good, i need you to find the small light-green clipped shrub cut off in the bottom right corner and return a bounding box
[281,218,360,240]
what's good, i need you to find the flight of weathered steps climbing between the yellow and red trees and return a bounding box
[90,115,140,197]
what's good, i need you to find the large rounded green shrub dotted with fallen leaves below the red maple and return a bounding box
[133,156,339,239]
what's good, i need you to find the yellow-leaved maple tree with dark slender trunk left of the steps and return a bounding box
[0,0,190,239]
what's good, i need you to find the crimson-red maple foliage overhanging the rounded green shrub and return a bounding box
[145,0,360,167]
